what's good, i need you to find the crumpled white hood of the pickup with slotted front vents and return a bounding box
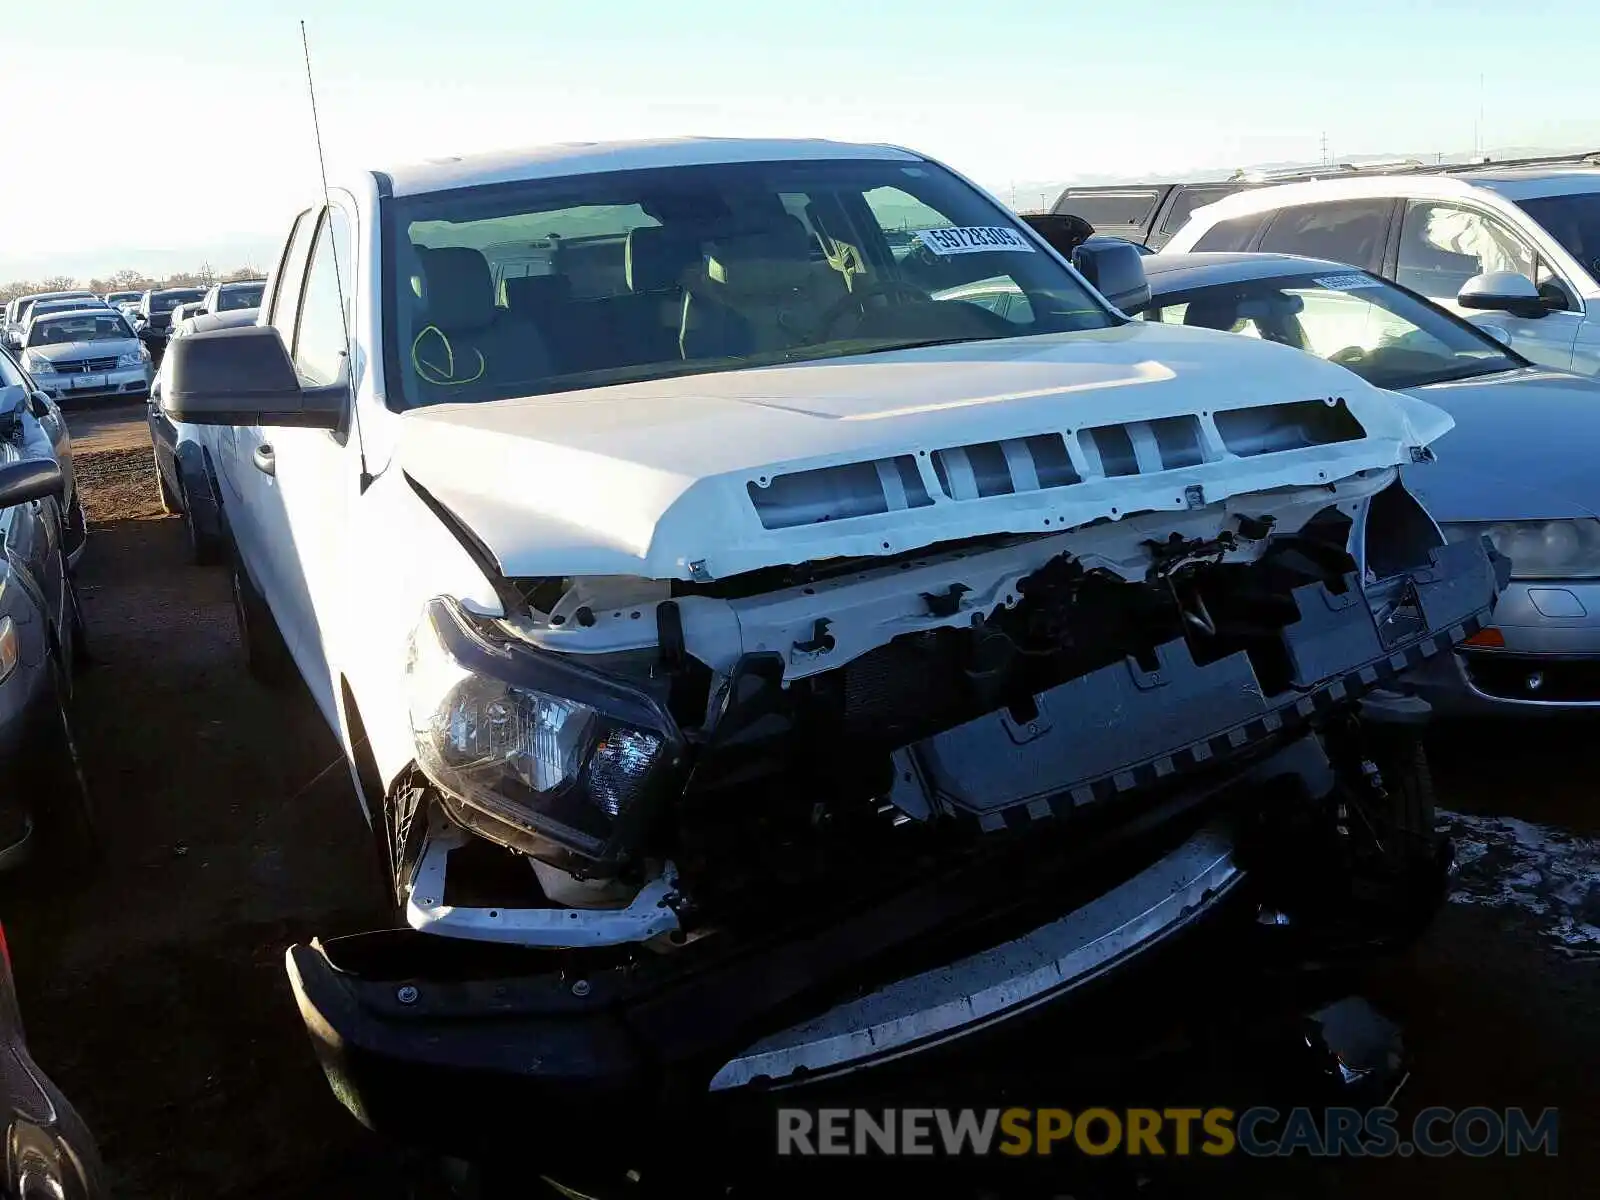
[400,322,1453,579]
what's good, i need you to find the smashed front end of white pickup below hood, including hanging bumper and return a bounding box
[290,469,1507,1158]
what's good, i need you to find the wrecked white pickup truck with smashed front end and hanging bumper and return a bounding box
[162,139,1504,1147]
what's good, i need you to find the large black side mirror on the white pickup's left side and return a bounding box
[162,325,350,429]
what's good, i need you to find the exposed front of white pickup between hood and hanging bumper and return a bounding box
[389,469,1498,950]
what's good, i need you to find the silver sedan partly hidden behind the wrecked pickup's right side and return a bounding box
[1139,254,1600,715]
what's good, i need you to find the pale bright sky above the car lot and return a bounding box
[0,0,1600,282]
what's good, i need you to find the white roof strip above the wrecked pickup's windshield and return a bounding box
[384,138,922,195]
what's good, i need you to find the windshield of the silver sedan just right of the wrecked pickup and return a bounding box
[1139,267,1523,389]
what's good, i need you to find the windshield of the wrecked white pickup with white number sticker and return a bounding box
[384,160,1117,406]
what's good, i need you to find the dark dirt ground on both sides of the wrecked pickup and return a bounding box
[0,408,1600,1200]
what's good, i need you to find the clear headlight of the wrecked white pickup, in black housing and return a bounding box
[406,600,683,864]
